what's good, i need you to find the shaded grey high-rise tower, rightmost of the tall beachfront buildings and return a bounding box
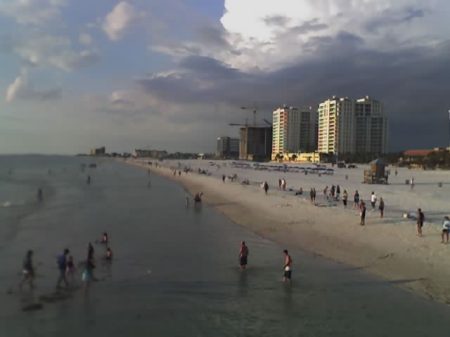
[355,96,388,154]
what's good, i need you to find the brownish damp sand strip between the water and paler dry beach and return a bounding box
[123,160,450,304]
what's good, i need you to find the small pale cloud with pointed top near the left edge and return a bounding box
[5,70,61,103]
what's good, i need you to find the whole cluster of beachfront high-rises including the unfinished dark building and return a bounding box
[217,96,388,162]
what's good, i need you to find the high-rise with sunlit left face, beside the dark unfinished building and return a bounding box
[272,106,316,155]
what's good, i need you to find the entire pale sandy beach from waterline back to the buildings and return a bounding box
[126,160,450,304]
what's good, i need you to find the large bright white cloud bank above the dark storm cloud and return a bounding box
[221,0,450,69]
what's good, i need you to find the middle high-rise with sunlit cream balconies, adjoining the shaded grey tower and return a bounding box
[317,96,355,154]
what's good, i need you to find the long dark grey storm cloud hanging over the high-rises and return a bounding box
[138,32,450,150]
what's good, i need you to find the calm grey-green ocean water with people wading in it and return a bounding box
[0,156,450,337]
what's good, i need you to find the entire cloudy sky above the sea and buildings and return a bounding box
[0,0,450,154]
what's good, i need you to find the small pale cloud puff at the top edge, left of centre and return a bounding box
[102,1,141,41]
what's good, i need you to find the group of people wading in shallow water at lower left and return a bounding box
[19,232,113,290]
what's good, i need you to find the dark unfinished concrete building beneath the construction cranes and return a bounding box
[239,126,272,161]
